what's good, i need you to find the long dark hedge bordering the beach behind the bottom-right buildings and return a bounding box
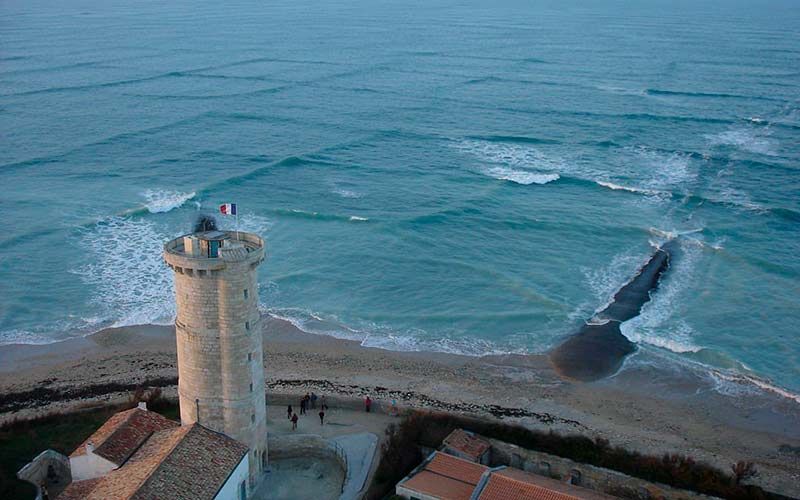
[368,412,785,499]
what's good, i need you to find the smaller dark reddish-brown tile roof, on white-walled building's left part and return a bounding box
[70,408,179,466]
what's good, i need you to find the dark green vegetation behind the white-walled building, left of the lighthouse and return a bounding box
[0,389,179,500]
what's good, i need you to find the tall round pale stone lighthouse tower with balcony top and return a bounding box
[164,231,267,484]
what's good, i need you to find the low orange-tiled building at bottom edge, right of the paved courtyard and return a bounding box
[395,451,615,500]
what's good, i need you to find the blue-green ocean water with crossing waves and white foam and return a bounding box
[0,0,800,397]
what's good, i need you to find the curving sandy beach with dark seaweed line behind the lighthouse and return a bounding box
[0,317,800,496]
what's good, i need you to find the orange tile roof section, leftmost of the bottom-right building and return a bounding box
[399,451,489,500]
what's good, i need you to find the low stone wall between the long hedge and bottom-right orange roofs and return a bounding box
[484,437,715,500]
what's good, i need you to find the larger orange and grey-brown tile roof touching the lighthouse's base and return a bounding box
[58,410,247,500]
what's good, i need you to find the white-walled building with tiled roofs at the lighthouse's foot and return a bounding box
[18,403,252,500]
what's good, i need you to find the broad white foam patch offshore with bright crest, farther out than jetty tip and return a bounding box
[455,140,565,185]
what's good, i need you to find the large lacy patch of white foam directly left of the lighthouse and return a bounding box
[72,217,175,327]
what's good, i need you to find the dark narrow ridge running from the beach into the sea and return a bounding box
[549,239,678,382]
